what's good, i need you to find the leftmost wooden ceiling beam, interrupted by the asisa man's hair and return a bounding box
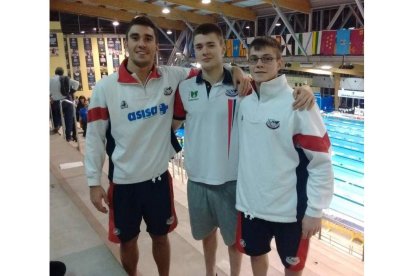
[50,0,186,30]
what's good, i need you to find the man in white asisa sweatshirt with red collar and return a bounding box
[85,16,249,276]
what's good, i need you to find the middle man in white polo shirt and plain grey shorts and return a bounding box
[174,24,313,276]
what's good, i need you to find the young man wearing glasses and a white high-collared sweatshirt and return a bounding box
[236,37,333,276]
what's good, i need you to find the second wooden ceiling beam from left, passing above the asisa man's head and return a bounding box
[82,0,216,24]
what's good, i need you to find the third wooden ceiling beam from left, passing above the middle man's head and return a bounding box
[168,0,256,21]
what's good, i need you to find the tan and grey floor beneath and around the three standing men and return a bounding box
[50,131,364,276]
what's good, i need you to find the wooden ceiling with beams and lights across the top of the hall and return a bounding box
[50,0,363,33]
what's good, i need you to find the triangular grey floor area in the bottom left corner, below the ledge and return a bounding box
[50,173,126,276]
